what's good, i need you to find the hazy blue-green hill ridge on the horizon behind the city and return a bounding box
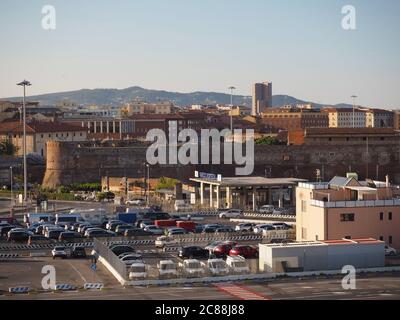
[1,86,354,107]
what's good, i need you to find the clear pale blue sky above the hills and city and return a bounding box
[0,0,400,107]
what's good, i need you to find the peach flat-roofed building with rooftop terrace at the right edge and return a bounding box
[296,175,400,249]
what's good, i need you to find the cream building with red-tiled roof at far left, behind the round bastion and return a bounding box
[0,121,87,158]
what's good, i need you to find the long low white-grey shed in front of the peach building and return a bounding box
[259,238,385,273]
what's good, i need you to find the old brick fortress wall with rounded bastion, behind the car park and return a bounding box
[43,142,400,187]
